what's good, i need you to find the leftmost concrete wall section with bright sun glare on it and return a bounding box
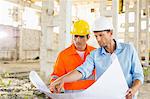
[0,25,18,60]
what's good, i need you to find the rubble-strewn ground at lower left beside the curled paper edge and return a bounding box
[0,72,47,99]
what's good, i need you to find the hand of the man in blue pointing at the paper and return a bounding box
[50,78,64,93]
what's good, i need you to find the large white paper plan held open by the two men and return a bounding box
[29,58,128,99]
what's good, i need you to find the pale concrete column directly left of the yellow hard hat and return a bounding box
[59,0,72,51]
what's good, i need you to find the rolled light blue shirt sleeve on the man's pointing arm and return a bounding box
[76,52,95,79]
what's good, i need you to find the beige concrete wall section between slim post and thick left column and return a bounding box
[20,29,41,60]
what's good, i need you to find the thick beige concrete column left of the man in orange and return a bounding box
[40,0,54,81]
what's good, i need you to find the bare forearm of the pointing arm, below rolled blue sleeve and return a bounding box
[61,70,82,83]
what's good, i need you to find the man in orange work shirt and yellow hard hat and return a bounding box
[50,20,95,93]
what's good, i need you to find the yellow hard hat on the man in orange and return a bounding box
[70,20,90,36]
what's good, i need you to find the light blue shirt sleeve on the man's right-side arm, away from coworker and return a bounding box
[131,45,144,84]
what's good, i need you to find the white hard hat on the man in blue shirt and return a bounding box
[92,16,113,31]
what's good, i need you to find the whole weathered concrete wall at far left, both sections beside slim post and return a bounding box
[0,25,41,60]
